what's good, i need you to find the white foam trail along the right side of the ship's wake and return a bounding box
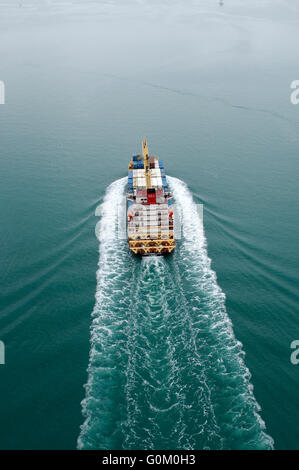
[168,177,274,449]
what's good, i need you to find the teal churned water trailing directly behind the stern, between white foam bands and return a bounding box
[122,257,221,449]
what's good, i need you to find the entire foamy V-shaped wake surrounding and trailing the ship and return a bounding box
[78,178,273,449]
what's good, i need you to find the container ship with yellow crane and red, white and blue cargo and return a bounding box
[127,139,175,256]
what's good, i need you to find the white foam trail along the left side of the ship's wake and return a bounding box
[78,178,132,449]
